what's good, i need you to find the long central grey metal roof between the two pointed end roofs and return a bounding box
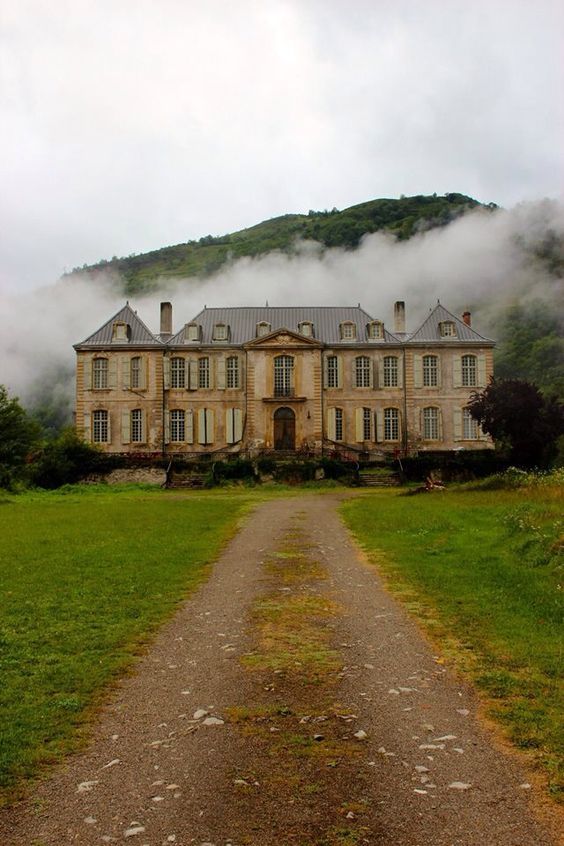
[169,306,398,346]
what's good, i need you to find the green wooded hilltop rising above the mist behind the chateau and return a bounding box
[67,194,486,295]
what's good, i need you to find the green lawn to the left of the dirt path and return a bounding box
[0,488,249,796]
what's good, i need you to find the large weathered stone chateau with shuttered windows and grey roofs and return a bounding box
[75,302,494,460]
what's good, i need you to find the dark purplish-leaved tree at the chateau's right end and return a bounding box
[468,379,564,467]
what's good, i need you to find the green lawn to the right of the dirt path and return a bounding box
[342,486,564,793]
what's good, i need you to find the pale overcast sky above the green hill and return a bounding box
[0,0,564,293]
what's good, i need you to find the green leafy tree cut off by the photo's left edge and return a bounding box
[0,385,40,488]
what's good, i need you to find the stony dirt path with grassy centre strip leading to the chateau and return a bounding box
[0,496,555,846]
